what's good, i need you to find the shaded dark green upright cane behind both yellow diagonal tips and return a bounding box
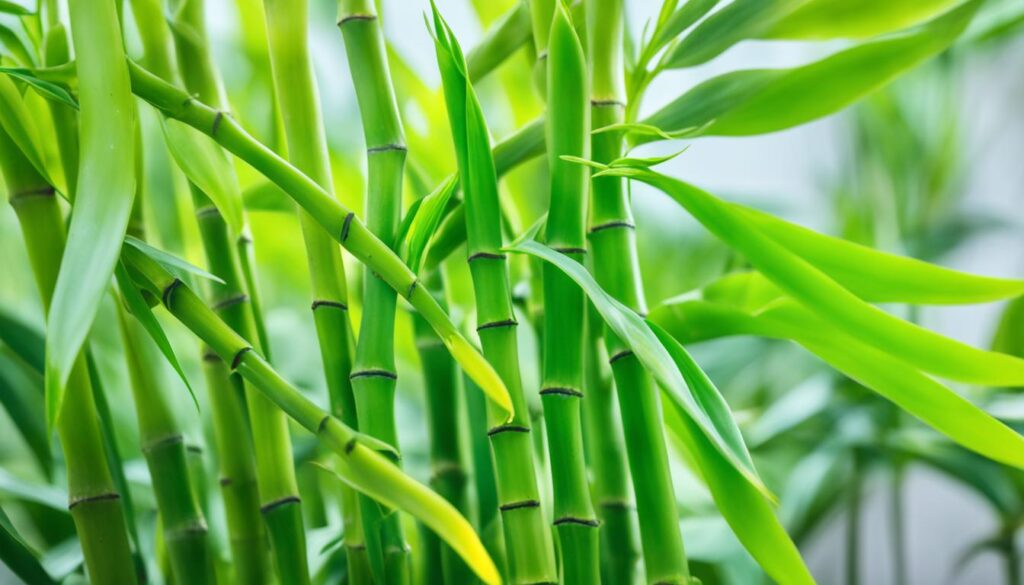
[413,270,470,583]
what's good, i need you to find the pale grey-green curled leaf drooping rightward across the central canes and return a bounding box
[505,239,771,497]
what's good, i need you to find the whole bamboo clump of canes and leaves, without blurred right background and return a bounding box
[0,0,1024,585]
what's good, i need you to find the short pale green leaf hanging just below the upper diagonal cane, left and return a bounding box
[161,118,244,235]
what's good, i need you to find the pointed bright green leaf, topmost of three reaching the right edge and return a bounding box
[732,204,1024,304]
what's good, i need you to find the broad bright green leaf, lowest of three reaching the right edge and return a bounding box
[650,300,1024,468]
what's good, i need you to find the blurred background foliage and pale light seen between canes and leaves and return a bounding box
[0,0,1024,585]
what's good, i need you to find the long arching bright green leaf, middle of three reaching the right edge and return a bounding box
[595,168,1024,386]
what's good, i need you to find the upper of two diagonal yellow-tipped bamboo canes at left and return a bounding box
[128,61,513,416]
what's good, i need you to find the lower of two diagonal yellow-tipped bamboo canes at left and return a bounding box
[122,247,501,585]
